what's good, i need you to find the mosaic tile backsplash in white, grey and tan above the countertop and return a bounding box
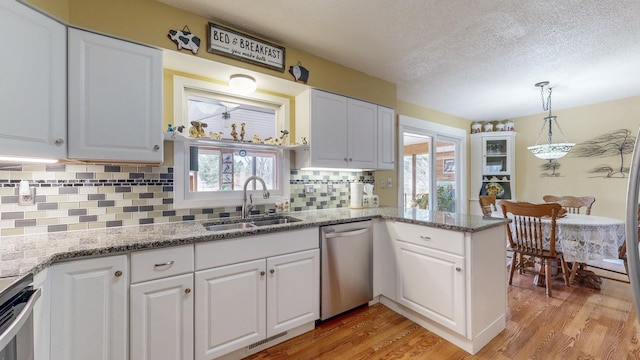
[0,164,375,236]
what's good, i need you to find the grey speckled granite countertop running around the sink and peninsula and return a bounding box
[0,207,508,277]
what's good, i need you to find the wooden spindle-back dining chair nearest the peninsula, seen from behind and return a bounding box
[500,201,569,296]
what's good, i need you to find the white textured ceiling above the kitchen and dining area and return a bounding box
[160,0,640,120]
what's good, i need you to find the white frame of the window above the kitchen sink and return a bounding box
[173,75,291,209]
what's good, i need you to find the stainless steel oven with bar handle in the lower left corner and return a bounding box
[0,275,40,360]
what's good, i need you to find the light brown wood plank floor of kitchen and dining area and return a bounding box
[247,274,640,360]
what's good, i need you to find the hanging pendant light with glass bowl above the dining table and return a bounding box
[527,81,575,161]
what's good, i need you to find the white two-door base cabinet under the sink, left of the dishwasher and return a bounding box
[195,232,320,360]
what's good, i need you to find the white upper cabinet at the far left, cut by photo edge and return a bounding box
[0,1,67,159]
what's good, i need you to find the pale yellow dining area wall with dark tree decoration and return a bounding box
[513,97,640,218]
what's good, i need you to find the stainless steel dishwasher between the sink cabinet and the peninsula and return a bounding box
[320,221,373,320]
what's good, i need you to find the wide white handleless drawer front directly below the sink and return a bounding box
[195,227,320,270]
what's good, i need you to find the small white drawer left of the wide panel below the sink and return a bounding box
[131,245,194,283]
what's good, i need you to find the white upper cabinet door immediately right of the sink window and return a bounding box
[309,90,348,168]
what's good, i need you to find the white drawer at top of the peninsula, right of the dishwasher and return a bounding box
[391,221,464,255]
